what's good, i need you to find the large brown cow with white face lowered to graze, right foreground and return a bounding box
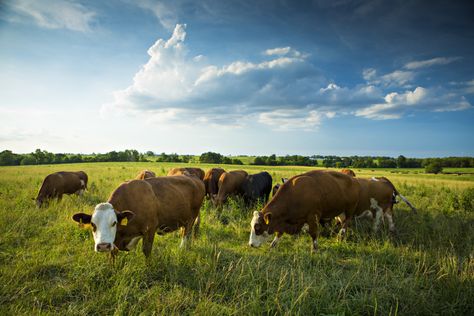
[249,170,359,250]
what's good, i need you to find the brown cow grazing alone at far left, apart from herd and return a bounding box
[36,171,88,207]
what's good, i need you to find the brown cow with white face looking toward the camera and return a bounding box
[73,176,205,258]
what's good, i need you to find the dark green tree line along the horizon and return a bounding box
[0,149,474,169]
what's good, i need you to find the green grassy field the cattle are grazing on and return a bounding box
[0,163,474,315]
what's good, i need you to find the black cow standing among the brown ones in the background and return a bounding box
[241,171,273,204]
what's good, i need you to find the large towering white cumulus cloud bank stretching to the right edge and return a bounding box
[102,24,471,130]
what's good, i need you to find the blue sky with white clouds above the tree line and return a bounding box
[0,0,474,157]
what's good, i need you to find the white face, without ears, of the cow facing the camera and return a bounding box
[91,203,118,252]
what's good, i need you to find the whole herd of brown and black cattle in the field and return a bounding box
[36,168,416,258]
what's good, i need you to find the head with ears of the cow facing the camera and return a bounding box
[72,203,135,252]
